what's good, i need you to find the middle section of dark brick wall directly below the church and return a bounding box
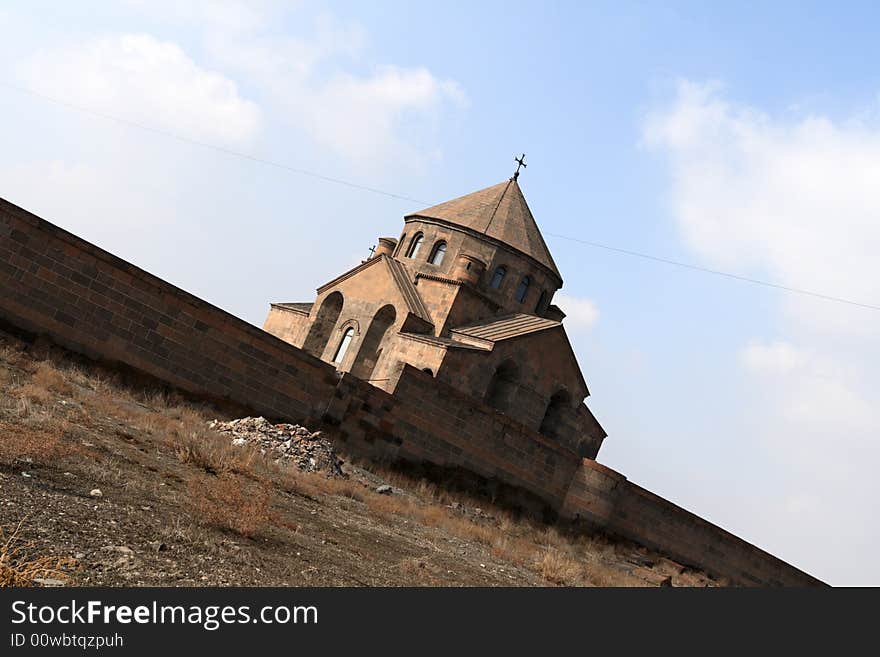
[328,364,580,509]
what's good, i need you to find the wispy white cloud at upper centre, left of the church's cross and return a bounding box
[197,16,468,169]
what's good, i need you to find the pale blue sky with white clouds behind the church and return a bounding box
[0,0,880,585]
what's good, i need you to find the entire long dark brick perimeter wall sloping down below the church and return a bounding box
[0,200,819,585]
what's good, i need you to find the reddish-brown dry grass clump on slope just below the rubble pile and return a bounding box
[188,474,273,537]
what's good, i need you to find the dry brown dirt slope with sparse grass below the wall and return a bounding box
[0,333,726,586]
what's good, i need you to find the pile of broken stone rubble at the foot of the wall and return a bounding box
[208,417,345,477]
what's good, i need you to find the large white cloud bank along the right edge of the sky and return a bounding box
[643,82,880,584]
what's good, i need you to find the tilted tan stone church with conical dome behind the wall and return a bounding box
[264,175,606,458]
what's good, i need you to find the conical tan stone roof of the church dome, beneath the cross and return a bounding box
[406,178,562,280]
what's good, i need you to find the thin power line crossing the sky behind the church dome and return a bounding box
[0,80,880,311]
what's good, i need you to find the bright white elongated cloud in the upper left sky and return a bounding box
[18,34,260,143]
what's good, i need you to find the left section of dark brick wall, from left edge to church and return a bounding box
[0,200,337,421]
